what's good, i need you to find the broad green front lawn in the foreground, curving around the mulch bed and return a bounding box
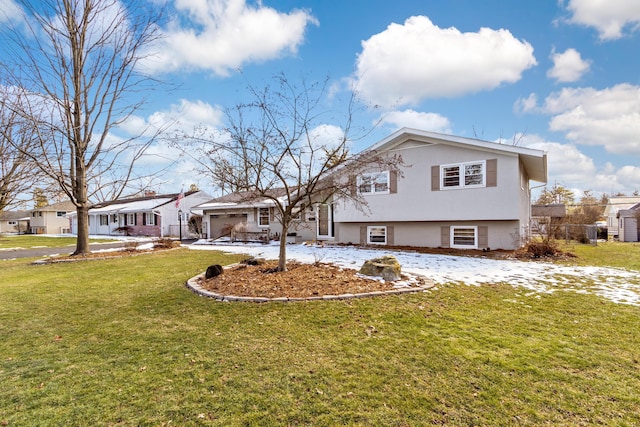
[0,249,640,426]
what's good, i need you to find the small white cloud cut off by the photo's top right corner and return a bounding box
[567,0,640,40]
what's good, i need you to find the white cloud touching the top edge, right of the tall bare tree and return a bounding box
[142,0,317,76]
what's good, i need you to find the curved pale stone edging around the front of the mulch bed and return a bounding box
[185,264,435,302]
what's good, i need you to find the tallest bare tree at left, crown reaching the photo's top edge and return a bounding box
[5,0,159,255]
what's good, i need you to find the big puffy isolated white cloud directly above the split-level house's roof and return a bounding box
[355,16,536,106]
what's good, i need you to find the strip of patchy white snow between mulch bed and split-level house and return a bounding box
[189,240,640,306]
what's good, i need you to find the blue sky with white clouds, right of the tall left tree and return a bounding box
[0,0,640,199]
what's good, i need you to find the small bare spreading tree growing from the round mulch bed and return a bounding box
[182,75,402,271]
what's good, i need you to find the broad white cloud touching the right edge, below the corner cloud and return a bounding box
[543,84,640,156]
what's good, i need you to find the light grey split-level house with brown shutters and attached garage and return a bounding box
[200,128,547,249]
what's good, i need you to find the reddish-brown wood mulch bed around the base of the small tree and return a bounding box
[199,261,422,298]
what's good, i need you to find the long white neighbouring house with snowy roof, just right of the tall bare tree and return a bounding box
[70,190,211,237]
